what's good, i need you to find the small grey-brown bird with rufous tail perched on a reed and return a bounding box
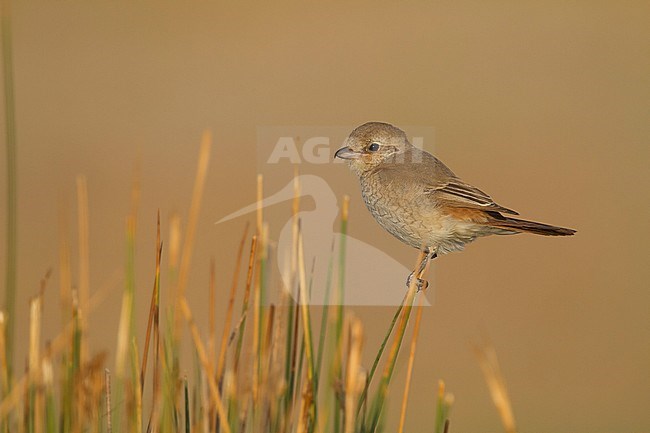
[334,122,576,291]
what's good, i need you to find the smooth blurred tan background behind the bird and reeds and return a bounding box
[0,1,650,432]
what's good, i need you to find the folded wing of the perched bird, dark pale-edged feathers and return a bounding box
[427,177,519,215]
